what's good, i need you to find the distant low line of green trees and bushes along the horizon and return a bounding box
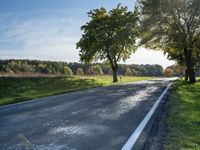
[0,59,164,76]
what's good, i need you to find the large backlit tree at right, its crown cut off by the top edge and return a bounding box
[139,0,200,83]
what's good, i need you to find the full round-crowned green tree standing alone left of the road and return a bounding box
[77,4,138,82]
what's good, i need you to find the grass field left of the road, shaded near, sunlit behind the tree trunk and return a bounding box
[0,76,155,105]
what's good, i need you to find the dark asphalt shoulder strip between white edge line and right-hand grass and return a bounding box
[133,87,171,150]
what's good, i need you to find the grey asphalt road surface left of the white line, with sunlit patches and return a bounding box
[0,79,171,150]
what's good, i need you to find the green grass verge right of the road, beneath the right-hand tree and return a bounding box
[166,78,200,150]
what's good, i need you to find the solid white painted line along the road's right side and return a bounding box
[121,80,174,150]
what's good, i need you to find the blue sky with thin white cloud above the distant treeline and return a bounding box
[0,0,174,68]
